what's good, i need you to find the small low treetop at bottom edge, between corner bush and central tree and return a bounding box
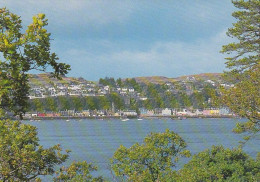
[53,161,104,182]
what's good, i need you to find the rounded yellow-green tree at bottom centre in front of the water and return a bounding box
[111,129,190,181]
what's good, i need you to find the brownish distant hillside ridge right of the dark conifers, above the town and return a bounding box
[135,73,223,84]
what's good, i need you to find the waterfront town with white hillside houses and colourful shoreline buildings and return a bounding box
[21,74,234,119]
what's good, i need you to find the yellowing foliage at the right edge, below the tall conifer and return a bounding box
[223,67,260,134]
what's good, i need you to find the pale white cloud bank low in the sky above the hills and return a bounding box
[63,28,234,77]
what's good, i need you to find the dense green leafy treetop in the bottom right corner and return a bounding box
[175,146,260,182]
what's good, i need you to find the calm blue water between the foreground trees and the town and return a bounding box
[22,119,260,181]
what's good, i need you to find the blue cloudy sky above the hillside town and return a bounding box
[0,0,236,81]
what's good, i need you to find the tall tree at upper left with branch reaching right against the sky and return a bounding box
[0,8,70,118]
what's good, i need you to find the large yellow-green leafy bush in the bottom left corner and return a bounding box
[0,120,69,181]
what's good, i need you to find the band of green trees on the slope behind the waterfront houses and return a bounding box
[29,78,218,112]
